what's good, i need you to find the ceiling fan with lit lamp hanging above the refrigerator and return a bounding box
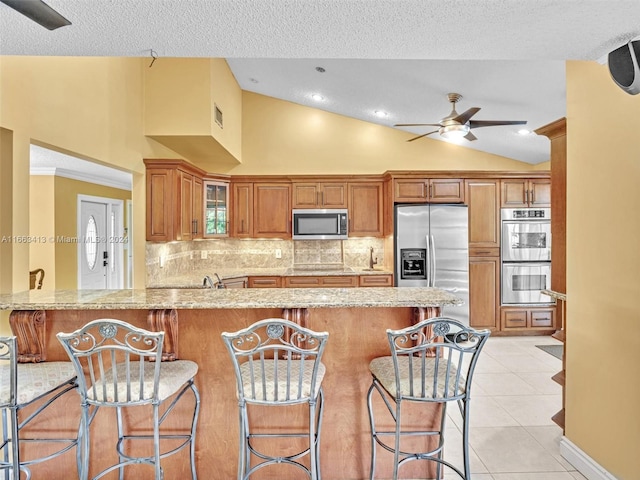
[394,93,527,142]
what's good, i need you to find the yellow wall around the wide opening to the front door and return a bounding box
[0,56,148,293]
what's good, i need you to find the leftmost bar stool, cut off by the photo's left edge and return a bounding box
[0,336,78,480]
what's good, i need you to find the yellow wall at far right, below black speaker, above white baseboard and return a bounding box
[566,62,640,480]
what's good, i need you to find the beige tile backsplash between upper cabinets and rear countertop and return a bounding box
[146,238,384,285]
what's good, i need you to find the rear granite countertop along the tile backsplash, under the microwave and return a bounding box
[147,265,393,289]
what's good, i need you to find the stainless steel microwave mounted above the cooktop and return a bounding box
[292,208,349,240]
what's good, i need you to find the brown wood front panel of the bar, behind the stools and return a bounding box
[25,308,439,480]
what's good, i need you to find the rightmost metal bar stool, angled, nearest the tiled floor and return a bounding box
[367,317,490,480]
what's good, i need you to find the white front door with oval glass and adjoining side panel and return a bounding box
[78,195,124,290]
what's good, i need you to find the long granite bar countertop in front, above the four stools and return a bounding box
[0,287,463,310]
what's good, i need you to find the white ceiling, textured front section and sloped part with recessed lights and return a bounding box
[0,0,640,163]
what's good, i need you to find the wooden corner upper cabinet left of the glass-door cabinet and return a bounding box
[144,160,204,242]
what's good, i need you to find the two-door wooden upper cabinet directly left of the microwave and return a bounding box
[231,182,291,238]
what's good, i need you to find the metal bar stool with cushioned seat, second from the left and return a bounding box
[57,318,200,480]
